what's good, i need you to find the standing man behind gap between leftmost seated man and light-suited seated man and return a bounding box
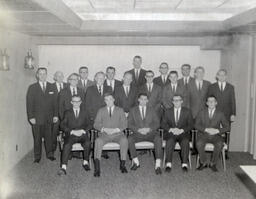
[85,72,112,125]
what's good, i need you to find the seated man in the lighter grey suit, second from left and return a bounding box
[94,93,128,177]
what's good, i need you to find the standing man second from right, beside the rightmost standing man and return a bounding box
[188,66,211,119]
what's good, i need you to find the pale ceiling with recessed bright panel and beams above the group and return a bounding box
[0,0,256,36]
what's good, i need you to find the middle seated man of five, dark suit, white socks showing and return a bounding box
[128,93,162,175]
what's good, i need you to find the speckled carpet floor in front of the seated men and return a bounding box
[2,152,256,199]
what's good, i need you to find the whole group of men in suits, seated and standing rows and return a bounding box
[27,56,236,177]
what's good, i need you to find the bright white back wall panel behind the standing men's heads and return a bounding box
[39,45,220,81]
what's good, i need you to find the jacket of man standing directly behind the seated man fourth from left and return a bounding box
[162,83,188,109]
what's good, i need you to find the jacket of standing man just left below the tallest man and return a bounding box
[114,84,137,113]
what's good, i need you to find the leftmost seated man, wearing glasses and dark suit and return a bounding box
[58,95,91,175]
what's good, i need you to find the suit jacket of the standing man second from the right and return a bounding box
[188,80,211,119]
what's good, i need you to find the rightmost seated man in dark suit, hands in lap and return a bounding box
[195,95,230,172]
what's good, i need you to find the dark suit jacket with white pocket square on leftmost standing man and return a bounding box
[26,82,58,125]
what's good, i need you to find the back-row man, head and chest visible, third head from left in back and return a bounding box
[77,66,95,94]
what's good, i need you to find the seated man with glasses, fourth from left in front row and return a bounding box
[161,94,194,172]
